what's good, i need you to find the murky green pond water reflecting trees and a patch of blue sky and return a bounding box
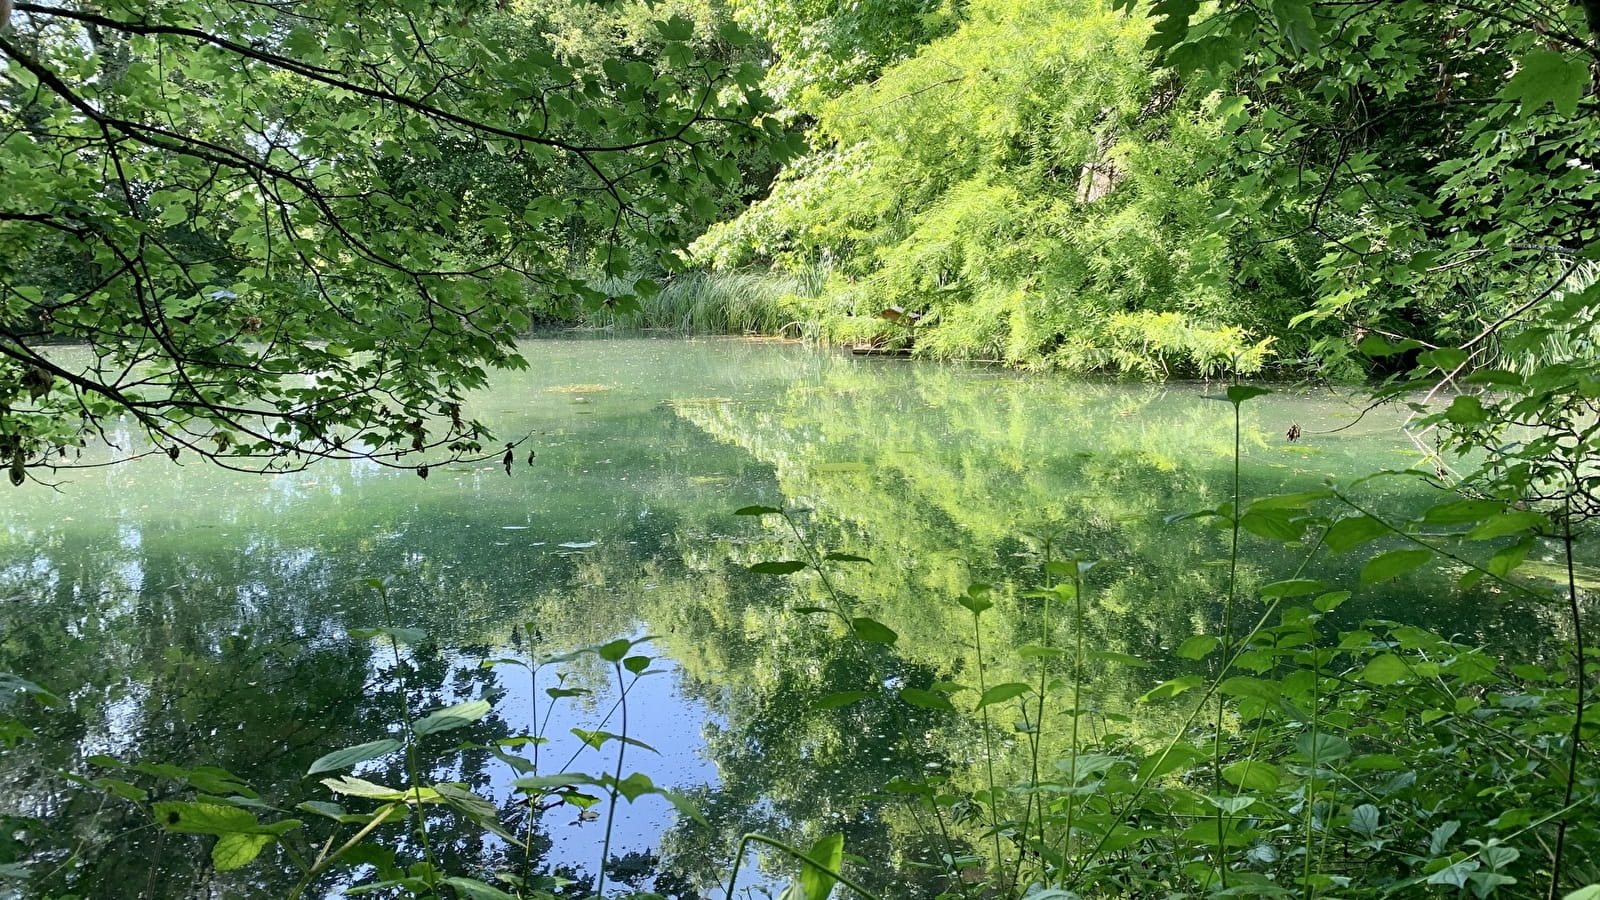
[0,340,1546,897]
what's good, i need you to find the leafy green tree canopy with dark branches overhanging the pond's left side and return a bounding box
[0,0,782,482]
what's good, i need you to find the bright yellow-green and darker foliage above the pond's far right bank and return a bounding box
[696,0,1595,376]
